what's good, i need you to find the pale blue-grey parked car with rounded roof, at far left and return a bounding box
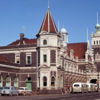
[1,86,18,96]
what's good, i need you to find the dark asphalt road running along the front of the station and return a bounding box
[0,93,100,100]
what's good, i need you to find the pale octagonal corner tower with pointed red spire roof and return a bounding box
[37,7,63,90]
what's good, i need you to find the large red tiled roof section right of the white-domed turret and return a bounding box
[68,42,87,59]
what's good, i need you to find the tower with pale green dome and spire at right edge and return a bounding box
[91,13,100,72]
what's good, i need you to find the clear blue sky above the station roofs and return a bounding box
[0,0,100,46]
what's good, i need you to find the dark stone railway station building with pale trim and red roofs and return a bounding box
[0,5,100,93]
